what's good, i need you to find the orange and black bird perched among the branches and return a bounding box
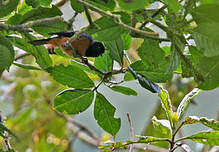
[29,31,105,57]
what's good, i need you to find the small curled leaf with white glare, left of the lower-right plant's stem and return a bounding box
[152,116,172,133]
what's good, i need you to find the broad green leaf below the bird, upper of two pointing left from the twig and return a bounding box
[48,64,94,89]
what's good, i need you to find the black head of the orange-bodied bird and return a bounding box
[86,42,105,57]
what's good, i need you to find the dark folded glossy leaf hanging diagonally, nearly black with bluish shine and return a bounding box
[128,67,160,93]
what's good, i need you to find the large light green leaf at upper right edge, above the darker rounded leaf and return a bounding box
[192,4,219,57]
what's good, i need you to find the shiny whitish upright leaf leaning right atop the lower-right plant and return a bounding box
[177,88,201,119]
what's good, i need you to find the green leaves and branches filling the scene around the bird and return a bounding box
[0,0,219,152]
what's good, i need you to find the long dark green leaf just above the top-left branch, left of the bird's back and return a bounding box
[17,5,62,24]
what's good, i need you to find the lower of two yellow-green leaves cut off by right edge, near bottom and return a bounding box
[183,131,219,146]
